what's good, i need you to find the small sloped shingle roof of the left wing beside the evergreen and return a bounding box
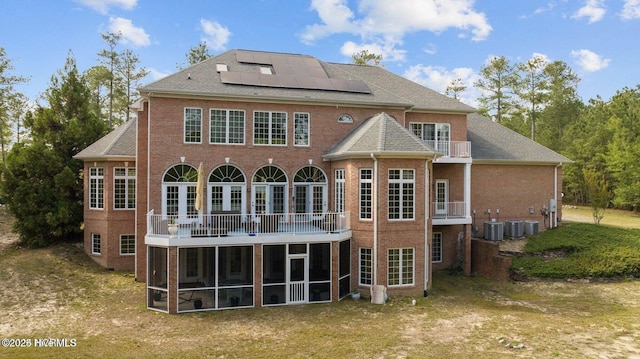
[73,120,137,161]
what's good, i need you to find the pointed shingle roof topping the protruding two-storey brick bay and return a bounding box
[322,112,437,160]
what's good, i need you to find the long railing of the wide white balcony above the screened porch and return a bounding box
[147,211,351,238]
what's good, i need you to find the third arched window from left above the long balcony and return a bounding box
[251,166,289,214]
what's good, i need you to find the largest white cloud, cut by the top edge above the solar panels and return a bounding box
[300,0,492,64]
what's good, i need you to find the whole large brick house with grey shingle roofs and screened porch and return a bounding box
[76,50,570,313]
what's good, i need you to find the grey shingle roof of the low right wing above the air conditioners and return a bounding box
[467,113,573,164]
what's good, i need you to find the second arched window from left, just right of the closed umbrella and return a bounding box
[208,165,247,214]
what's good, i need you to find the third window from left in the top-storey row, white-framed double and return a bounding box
[253,111,287,146]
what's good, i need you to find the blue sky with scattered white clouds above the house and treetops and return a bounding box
[0,0,640,106]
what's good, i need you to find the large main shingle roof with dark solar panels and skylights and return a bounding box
[139,50,475,113]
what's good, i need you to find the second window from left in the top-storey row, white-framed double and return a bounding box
[209,108,245,145]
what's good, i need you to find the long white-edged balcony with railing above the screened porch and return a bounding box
[145,210,351,245]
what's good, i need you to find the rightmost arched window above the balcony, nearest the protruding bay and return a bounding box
[293,166,328,218]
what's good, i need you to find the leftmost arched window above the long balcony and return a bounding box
[162,164,198,218]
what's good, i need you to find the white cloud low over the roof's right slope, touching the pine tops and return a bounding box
[402,65,479,107]
